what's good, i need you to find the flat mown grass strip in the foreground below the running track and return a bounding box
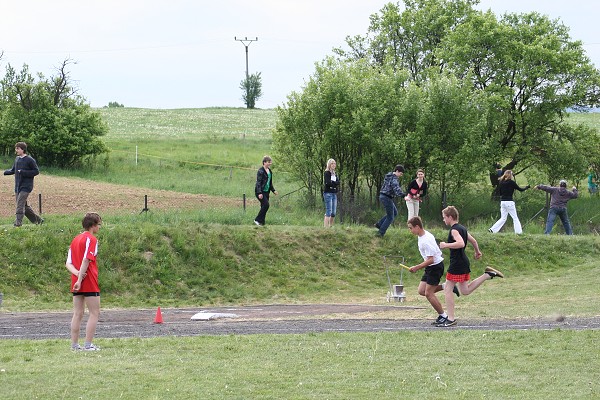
[0,330,600,399]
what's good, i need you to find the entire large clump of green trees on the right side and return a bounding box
[275,0,600,212]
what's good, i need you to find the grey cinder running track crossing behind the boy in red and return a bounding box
[0,304,600,339]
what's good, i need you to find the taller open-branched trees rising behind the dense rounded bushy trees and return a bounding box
[336,0,600,182]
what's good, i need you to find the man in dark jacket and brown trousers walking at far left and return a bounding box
[4,142,44,227]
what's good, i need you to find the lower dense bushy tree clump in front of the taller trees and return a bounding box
[274,58,486,212]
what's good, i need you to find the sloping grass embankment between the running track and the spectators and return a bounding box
[0,215,600,317]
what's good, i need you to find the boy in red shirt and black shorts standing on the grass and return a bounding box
[65,213,102,351]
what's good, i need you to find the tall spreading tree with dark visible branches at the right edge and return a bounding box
[438,12,600,177]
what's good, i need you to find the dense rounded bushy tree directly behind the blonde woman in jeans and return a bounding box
[274,58,406,202]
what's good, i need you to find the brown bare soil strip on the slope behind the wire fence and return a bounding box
[0,175,242,217]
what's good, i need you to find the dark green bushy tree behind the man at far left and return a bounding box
[0,60,107,167]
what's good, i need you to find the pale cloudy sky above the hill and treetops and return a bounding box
[0,0,600,109]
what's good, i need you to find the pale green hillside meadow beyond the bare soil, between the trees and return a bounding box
[45,108,284,197]
